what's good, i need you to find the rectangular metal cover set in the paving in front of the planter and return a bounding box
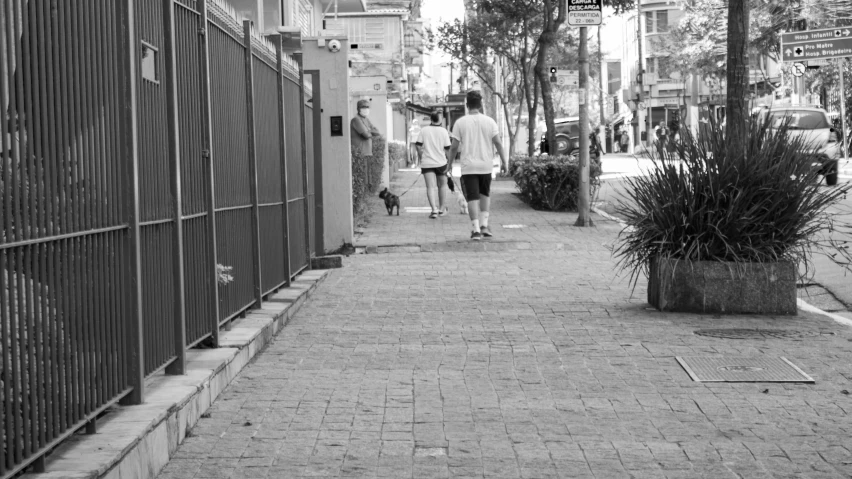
[675,356,814,383]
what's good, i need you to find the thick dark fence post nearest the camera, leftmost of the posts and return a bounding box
[120,0,145,405]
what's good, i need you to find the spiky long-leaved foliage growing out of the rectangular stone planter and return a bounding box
[614,116,850,285]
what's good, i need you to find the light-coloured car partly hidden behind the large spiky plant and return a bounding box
[759,106,840,186]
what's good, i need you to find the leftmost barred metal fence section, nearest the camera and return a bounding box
[0,0,135,477]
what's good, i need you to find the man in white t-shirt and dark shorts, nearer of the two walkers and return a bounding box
[449,91,509,241]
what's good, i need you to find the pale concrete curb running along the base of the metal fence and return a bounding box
[23,270,330,479]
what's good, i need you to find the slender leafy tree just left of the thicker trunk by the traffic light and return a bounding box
[429,0,541,155]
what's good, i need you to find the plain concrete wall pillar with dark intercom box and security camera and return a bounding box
[302,37,354,256]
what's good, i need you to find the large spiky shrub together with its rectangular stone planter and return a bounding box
[614,115,852,313]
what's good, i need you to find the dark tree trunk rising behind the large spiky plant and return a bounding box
[725,0,749,158]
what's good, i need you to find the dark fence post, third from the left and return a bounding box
[198,0,219,347]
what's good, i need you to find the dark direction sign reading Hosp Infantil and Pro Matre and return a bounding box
[781,27,852,62]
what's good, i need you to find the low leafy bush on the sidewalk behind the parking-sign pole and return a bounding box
[509,156,601,211]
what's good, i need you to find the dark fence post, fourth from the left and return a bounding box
[243,20,263,308]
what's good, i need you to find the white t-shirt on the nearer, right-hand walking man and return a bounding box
[452,113,499,175]
